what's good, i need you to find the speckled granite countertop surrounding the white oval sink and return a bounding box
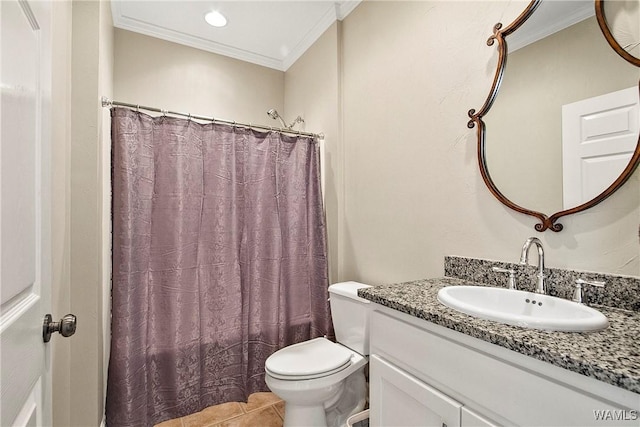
[358,277,640,393]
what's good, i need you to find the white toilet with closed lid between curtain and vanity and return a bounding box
[265,282,370,427]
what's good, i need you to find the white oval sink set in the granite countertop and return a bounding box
[438,286,609,332]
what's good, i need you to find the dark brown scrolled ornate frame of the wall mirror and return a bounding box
[467,0,640,232]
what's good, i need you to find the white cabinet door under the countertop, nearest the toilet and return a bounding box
[369,355,462,427]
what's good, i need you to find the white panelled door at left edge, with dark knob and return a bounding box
[0,0,51,426]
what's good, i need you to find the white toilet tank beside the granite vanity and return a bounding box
[329,282,371,355]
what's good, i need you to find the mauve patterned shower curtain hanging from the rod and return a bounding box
[106,108,332,427]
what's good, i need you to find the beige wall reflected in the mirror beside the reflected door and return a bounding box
[485,16,640,214]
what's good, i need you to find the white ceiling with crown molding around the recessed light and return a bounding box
[111,0,361,71]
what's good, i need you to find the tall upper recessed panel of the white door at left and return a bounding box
[0,1,38,304]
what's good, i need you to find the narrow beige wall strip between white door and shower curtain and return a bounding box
[67,1,113,426]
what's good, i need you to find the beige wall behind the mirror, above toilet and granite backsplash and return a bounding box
[332,1,640,283]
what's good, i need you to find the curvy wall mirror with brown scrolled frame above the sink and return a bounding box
[468,0,640,231]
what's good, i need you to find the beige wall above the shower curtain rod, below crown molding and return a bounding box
[114,29,284,126]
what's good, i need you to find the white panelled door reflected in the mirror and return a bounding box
[562,87,640,209]
